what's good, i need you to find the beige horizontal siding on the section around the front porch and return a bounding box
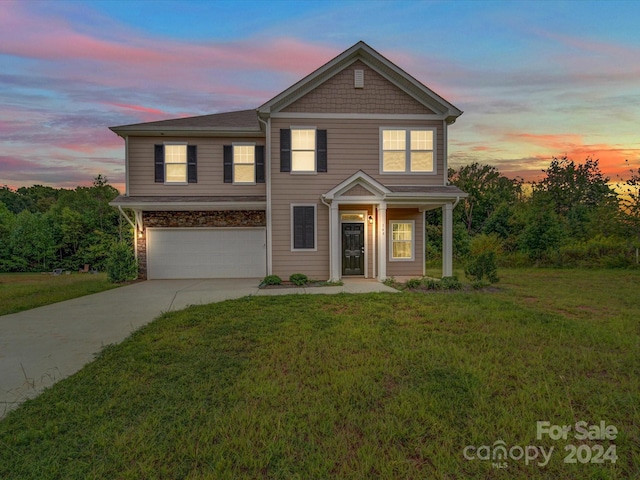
[271,117,444,279]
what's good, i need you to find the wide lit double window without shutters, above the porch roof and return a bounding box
[380,128,436,173]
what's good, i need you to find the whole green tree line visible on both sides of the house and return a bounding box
[0,157,640,272]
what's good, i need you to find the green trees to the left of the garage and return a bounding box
[0,175,132,272]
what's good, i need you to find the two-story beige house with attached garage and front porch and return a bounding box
[111,42,466,281]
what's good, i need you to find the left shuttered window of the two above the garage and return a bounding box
[155,143,198,185]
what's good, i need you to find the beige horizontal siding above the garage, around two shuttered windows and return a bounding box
[128,136,266,196]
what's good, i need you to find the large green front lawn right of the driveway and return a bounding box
[0,270,640,479]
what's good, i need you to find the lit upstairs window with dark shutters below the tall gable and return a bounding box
[280,127,327,173]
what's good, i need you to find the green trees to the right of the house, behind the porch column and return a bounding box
[426,156,640,267]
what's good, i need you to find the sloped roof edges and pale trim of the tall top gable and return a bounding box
[258,41,462,123]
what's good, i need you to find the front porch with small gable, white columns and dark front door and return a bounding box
[322,171,466,282]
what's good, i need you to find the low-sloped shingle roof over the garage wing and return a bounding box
[109,110,262,135]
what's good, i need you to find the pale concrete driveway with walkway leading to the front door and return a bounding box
[0,279,397,418]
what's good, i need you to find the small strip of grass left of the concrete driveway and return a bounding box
[0,273,117,315]
